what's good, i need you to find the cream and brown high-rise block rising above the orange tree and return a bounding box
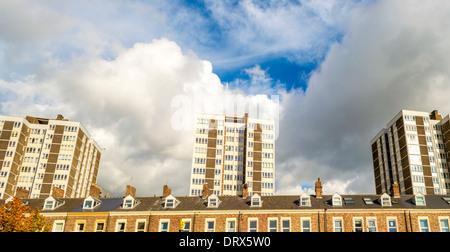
[0,115,101,199]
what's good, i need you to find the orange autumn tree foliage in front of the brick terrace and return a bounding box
[0,197,50,232]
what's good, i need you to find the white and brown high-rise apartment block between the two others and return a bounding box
[190,114,275,196]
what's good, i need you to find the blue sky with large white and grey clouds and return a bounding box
[0,0,450,196]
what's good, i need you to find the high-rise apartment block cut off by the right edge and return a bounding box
[371,110,450,195]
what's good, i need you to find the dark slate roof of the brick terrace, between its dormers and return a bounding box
[0,195,450,213]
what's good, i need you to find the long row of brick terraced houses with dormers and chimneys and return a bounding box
[0,178,450,232]
